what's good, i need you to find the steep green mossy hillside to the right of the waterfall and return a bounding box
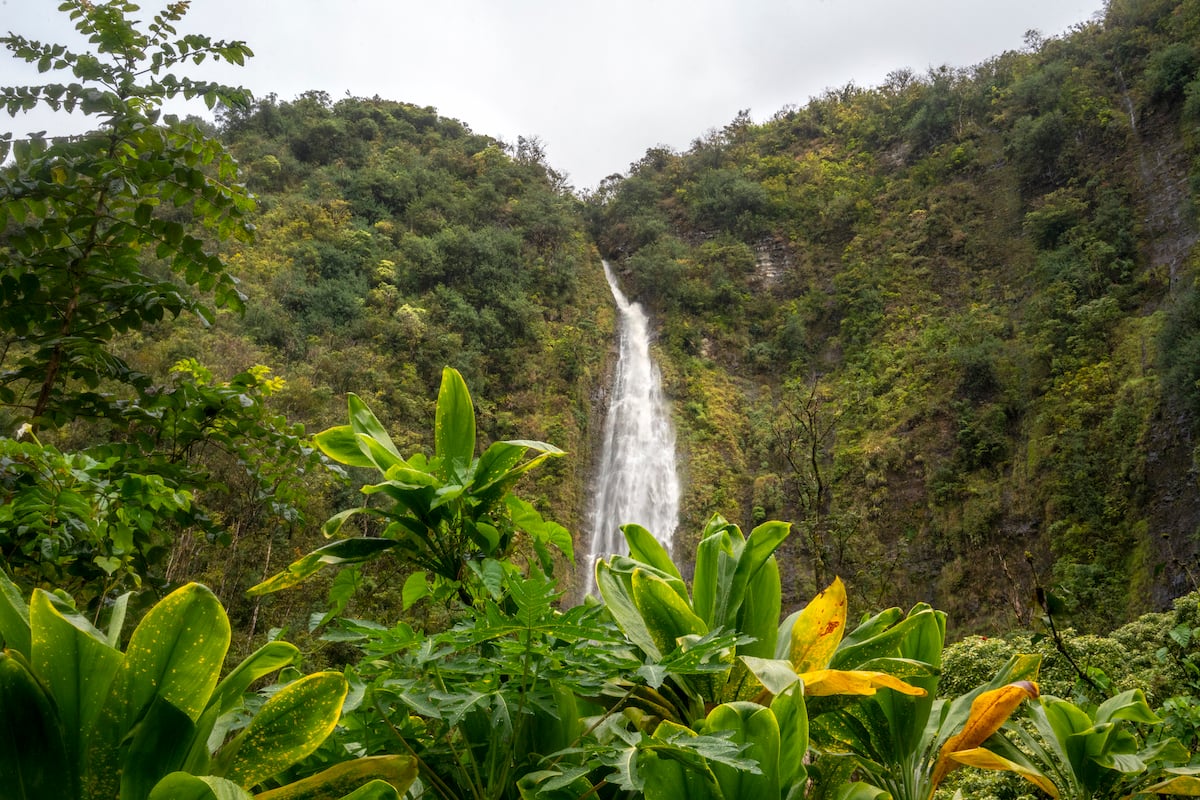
[589,0,1200,630]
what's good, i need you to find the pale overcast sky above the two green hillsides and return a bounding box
[0,0,1104,188]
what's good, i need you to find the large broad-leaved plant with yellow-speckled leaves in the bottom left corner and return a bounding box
[0,575,414,800]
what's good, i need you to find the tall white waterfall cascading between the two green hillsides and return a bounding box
[584,261,679,594]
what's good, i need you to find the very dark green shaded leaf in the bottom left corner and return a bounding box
[0,649,79,800]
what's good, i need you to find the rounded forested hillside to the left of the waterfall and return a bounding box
[110,92,613,627]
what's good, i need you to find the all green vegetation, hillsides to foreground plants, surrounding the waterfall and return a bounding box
[0,0,1200,800]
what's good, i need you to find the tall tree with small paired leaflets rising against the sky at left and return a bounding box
[0,0,254,426]
